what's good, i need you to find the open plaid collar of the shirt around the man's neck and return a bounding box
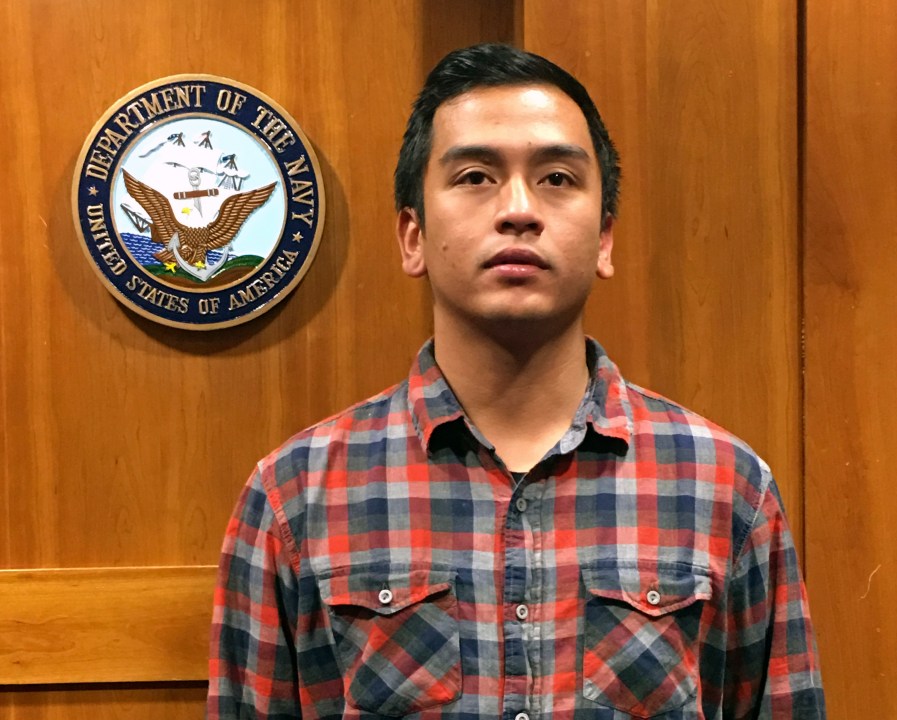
[408,337,632,451]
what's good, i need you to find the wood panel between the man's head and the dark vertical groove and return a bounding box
[524,0,802,542]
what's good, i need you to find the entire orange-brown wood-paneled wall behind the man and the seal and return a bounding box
[0,0,897,720]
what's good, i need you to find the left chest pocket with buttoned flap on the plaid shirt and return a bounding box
[319,565,461,716]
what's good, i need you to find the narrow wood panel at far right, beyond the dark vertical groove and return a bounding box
[804,0,897,718]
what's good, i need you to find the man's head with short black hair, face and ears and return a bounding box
[396,45,618,343]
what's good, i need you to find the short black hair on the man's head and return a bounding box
[394,43,620,223]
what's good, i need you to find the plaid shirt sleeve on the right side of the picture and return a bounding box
[724,477,825,720]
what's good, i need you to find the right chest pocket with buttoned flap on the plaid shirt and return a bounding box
[581,561,710,718]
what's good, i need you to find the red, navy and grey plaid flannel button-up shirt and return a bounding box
[207,340,825,720]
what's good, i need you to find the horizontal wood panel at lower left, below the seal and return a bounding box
[0,566,216,685]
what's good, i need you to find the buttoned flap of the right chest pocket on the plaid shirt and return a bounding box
[580,561,711,617]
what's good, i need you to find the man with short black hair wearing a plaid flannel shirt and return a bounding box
[208,45,825,720]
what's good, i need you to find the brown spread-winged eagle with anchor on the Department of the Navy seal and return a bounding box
[122,170,277,280]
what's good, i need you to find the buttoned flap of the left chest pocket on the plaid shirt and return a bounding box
[318,565,455,615]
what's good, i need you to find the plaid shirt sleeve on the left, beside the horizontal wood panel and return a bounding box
[206,472,301,720]
